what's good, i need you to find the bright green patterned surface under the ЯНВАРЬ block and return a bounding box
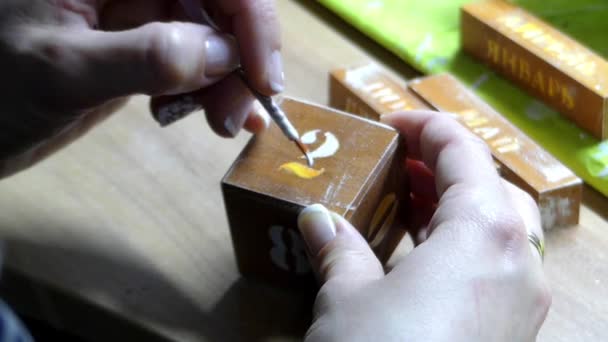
[319,0,608,195]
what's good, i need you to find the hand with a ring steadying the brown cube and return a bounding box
[299,111,551,341]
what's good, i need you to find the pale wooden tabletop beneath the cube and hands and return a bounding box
[0,0,608,341]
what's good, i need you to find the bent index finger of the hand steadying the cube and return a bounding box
[382,111,527,255]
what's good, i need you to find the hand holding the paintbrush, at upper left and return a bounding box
[0,0,283,177]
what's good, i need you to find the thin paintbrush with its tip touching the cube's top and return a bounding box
[180,0,314,167]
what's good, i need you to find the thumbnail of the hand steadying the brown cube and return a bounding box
[298,204,336,256]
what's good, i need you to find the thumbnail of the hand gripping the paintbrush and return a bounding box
[205,34,239,77]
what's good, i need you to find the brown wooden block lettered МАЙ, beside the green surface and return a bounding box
[409,74,582,229]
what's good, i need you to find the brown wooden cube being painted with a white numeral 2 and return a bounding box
[222,98,408,286]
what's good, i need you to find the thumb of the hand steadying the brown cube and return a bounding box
[298,204,384,291]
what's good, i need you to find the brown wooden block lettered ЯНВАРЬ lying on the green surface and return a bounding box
[461,0,608,139]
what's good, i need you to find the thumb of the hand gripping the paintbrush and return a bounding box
[28,22,239,107]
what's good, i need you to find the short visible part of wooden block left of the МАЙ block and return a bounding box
[329,63,430,121]
